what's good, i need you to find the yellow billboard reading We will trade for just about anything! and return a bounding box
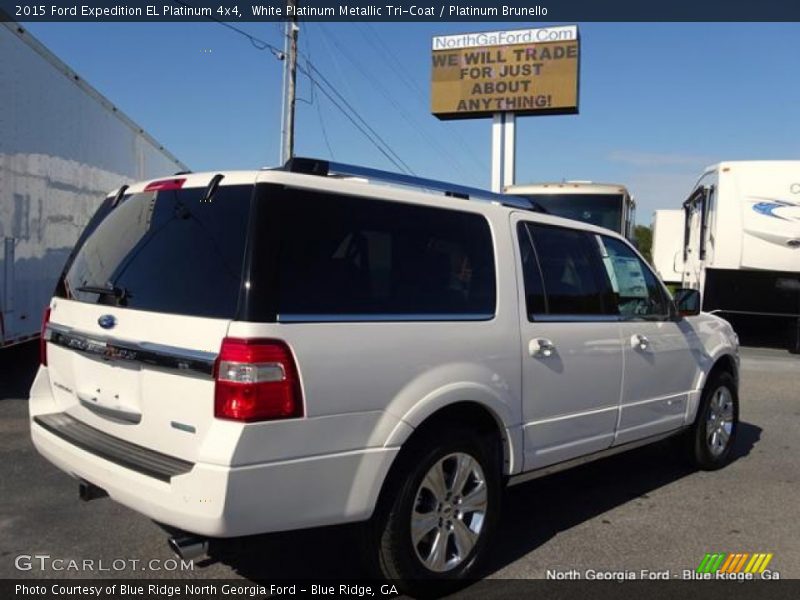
[431,26,580,119]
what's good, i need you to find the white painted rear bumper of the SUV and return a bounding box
[31,369,399,537]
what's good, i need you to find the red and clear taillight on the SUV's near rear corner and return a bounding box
[214,338,303,421]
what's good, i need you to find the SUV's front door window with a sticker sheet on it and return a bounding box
[597,235,669,320]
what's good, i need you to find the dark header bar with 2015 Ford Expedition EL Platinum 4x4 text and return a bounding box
[0,0,800,25]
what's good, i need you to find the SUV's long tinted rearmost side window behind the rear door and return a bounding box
[256,188,495,321]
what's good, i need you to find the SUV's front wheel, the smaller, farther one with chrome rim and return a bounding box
[684,372,739,471]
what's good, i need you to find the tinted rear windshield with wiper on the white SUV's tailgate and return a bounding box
[56,186,253,318]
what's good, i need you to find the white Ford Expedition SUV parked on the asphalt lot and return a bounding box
[30,159,738,582]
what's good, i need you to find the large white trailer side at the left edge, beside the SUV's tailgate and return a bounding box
[0,22,186,348]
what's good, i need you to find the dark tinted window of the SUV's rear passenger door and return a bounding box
[519,223,617,319]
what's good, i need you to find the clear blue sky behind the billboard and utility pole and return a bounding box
[21,23,800,224]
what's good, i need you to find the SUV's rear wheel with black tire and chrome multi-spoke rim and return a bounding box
[366,427,502,596]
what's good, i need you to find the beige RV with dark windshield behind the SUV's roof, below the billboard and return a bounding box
[505,181,636,239]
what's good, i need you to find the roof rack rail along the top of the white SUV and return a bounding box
[283,156,547,212]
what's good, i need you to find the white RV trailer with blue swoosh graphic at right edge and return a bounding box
[683,161,800,351]
